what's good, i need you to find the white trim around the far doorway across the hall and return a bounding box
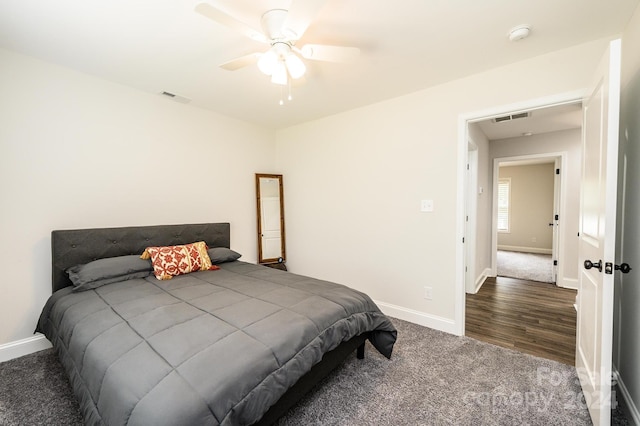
[491,152,567,285]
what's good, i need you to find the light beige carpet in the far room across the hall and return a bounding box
[498,250,554,283]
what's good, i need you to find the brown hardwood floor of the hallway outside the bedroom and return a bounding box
[465,277,576,365]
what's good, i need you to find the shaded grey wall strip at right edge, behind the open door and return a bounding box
[613,0,640,424]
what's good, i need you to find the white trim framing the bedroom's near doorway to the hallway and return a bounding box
[454,89,587,336]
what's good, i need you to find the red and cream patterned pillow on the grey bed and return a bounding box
[140,241,220,280]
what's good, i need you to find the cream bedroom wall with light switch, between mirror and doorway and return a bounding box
[277,40,607,330]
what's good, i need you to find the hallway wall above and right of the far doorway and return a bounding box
[490,129,582,288]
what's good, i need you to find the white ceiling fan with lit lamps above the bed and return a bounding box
[195,0,360,85]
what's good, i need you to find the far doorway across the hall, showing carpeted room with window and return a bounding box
[492,153,566,284]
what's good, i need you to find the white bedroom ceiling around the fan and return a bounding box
[0,0,638,128]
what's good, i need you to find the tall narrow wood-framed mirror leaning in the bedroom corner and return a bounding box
[256,173,286,270]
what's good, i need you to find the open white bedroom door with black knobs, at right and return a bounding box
[576,40,620,426]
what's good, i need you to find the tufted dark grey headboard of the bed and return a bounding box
[51,223,231,292]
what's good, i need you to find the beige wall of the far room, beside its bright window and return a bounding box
[498,163,555,254]
